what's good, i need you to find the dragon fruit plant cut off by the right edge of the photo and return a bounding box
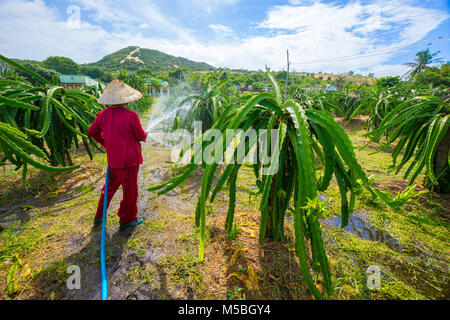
[367,95,450,193]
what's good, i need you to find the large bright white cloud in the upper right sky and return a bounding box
[251,0,448,72]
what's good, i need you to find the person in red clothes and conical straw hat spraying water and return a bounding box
[88,80,147,230]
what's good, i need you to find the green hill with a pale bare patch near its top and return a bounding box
[87,46,216,71]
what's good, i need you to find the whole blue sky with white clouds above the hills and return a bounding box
[0,0,450,76]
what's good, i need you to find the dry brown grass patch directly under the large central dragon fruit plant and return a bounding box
[201,210,312,300]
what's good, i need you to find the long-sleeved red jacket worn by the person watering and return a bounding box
[88,107,147,168]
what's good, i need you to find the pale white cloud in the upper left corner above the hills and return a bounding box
[0,1,112,62]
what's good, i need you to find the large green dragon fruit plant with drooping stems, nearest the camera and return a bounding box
[149,72,398,299]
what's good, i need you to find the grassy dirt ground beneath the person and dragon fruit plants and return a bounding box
[0,114,450,300]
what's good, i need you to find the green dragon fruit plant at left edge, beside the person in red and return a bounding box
[0,55,101,181]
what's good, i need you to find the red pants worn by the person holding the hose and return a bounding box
[95,166,139,225]
